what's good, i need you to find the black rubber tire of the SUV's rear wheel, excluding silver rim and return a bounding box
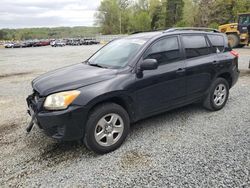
[203,78,229,111]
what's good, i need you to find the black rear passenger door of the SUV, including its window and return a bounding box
[181,34,217,101]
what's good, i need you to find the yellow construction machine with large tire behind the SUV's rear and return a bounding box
[219,13,250,48]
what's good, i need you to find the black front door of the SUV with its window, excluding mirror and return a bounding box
[136,36,186,117]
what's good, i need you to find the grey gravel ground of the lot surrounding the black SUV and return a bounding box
[0,45,250,187]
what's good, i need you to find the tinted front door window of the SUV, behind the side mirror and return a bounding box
[144,37,181,64]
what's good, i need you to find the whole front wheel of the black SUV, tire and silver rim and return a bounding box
[84,103,130,154]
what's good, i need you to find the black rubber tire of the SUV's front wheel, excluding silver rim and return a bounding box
[84,103,130,154]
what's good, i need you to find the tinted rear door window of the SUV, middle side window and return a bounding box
[182,35,211,59]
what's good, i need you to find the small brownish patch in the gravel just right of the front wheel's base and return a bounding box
[121,150,151,169]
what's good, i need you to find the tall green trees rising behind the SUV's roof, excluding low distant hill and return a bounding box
[95,0,250,34]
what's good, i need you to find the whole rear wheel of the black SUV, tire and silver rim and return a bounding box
[203,78,229,111]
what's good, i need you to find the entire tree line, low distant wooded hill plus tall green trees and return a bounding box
[0,0,250,40]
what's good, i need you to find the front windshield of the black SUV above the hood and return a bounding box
[88,39,146,68]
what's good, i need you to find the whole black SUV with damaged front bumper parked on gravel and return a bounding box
[27,28,239,153]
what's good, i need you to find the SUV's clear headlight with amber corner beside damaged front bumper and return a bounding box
[44,90,81,110]
